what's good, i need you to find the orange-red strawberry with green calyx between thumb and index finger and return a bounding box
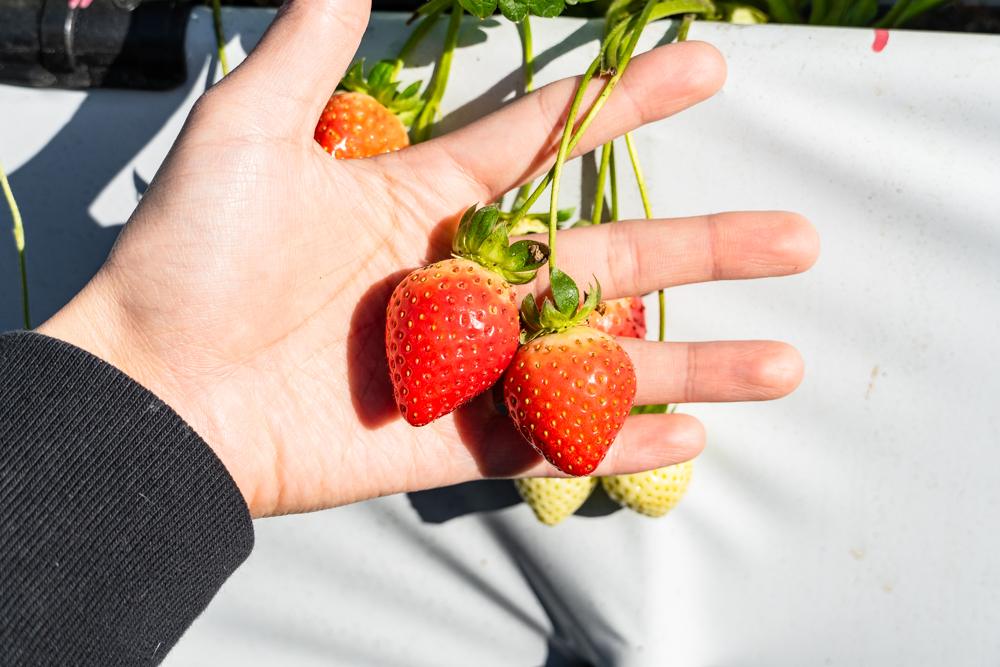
[313,60,423,159]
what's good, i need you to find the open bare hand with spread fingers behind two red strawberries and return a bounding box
[40,0,818,516]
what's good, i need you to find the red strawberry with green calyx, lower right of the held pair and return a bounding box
[503,269,636,476]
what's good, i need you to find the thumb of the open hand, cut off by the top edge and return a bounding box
[210,0,371,134]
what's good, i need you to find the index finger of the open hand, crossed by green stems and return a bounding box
[390,42,726,206]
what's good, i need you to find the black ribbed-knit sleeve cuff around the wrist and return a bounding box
[0,333,253,667]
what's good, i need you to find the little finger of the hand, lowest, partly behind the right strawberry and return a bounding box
[512,414,705,477]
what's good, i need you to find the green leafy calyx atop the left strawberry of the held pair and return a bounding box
[451,205,549,285]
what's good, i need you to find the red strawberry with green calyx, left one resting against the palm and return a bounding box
[385,206,548,426]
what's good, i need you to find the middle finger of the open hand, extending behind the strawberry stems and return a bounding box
[522,211,819,299]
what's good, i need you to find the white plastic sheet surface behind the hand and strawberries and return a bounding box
[0,10,1000,667]
